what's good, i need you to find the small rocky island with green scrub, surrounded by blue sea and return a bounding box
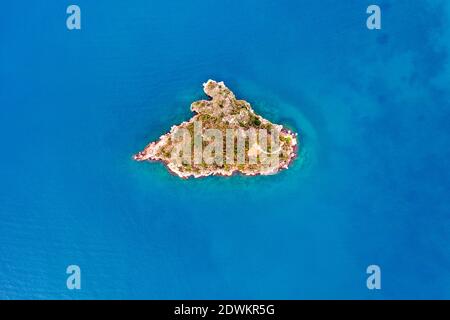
[133,80,298,178]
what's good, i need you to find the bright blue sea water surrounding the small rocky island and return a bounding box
[0,0,450,299]
